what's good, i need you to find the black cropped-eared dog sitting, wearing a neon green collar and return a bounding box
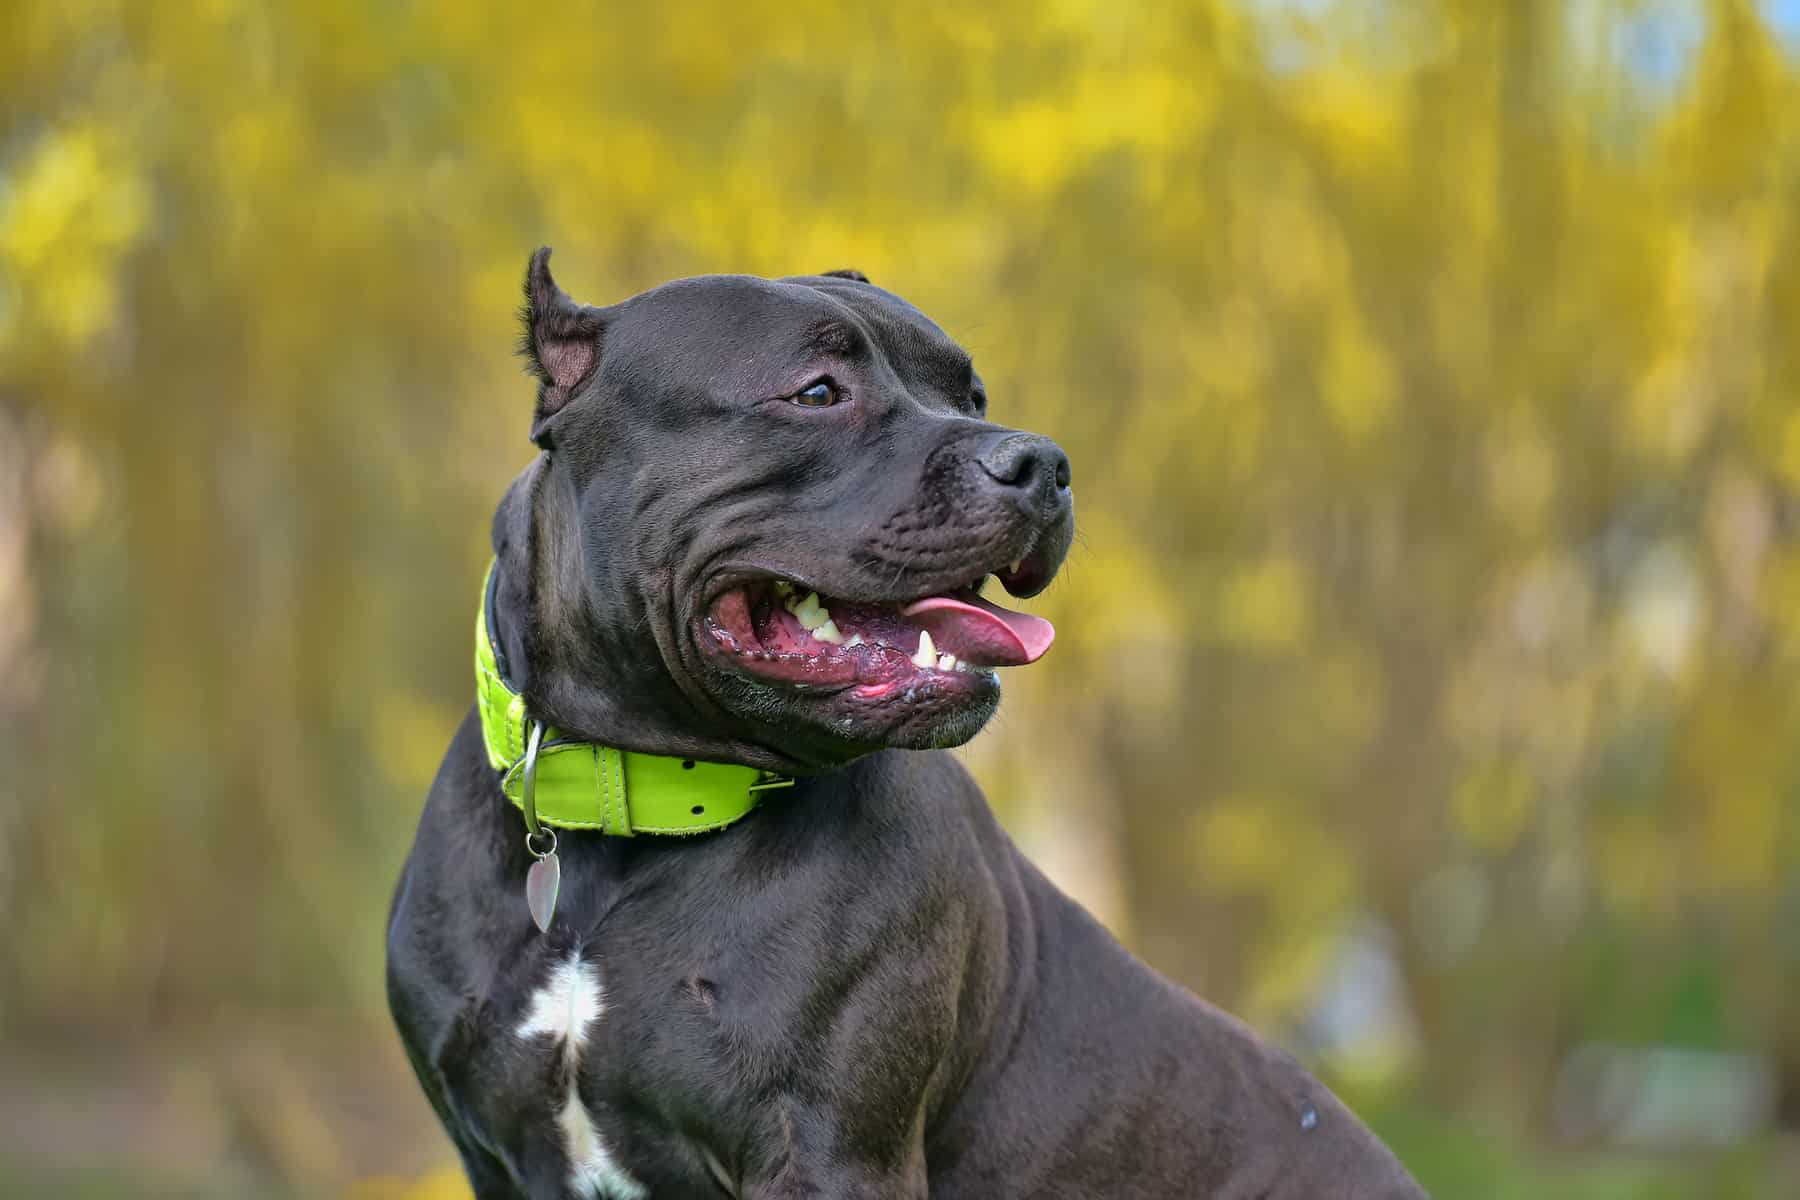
[387,248,1424,1200]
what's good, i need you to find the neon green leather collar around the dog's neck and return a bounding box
[475,567,794,837]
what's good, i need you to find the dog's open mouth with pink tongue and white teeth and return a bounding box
[707,576,1057,698]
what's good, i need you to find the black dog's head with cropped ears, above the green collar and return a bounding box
[497,250,1075,768]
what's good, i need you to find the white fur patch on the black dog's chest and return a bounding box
[517,952,650,1200]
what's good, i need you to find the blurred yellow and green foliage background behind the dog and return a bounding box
[0,0,1800,1200]
